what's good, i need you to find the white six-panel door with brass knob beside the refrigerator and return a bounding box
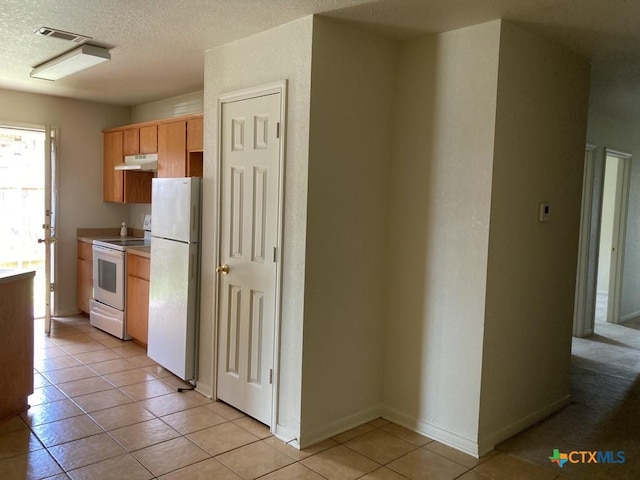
[218,93,281,425]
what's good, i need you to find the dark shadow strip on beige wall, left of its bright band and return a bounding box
[383,36,437,428]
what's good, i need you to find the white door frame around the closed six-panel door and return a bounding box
[213,80,287,433]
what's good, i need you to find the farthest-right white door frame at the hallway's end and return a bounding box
[605,148,631,323]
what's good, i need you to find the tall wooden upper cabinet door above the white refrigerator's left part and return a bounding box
[158,120,187,177]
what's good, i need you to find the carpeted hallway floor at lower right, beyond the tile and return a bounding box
[498,299,640,480]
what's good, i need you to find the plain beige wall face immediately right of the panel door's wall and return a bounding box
[300,17,397,445]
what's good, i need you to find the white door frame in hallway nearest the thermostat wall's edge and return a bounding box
[573,144,600,337]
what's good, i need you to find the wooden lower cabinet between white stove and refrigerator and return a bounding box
[126,252,151,345]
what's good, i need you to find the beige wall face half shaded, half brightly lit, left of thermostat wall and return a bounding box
[384,22,500,453]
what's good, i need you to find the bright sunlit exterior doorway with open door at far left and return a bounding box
[0,126,55,325]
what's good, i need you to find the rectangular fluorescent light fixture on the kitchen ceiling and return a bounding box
[31,44,111,80]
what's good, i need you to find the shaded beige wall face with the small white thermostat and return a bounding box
[479,22,589,453]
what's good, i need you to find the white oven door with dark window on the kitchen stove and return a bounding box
[93,245,125,311]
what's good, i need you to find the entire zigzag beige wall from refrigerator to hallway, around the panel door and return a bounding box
[199,17,588,454]
